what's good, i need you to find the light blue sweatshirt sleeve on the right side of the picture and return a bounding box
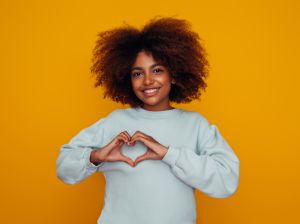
[162,117,240,198]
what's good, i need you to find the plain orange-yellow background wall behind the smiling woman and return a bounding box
[0,0,300,224]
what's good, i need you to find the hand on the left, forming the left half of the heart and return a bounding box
[95,131,134,167]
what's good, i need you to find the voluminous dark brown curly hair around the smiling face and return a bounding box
[90,16,209,107]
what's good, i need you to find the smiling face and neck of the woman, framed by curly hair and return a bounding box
[130,51,175,111]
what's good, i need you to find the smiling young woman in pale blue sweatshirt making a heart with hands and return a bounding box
[56,17,239,224]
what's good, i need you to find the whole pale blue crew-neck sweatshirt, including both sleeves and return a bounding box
[56,107,240,224]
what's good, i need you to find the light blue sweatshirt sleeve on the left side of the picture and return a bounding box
[56,118,105,184]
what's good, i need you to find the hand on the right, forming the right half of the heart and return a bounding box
[129,131,168,166]
